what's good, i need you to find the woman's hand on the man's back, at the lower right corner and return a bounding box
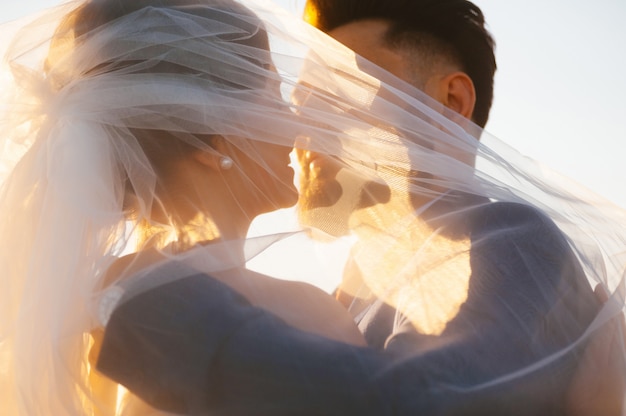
[566,285,626,416]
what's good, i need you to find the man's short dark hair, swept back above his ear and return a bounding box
[305,0,496,127]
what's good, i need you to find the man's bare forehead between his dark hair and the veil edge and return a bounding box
[328,19,411,82]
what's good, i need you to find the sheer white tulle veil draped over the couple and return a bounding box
[0,0,626,415]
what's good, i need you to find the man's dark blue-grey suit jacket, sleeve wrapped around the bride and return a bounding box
[98,203,598,416]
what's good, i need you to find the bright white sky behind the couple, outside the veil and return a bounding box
[0,0,626,207]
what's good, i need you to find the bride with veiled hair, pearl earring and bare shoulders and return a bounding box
[0,0,364,415]
